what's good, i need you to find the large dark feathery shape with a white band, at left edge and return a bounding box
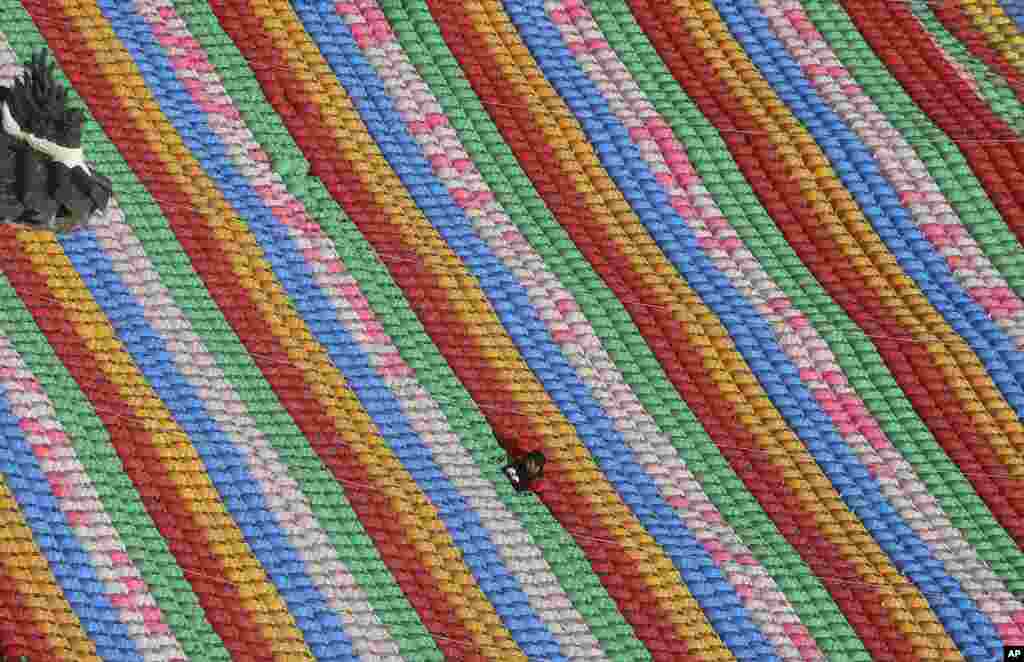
[0,50,112,233]
